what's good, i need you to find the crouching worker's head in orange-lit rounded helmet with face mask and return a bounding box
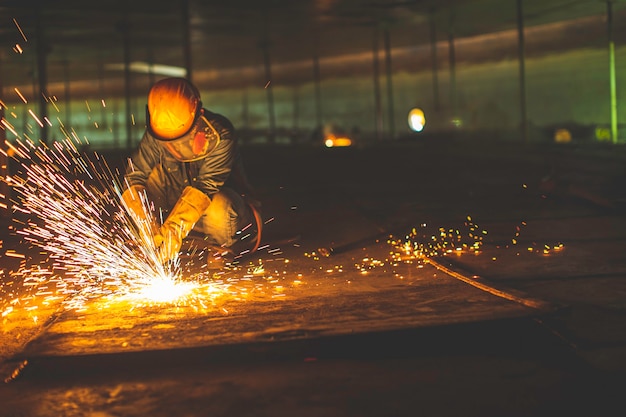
[146,77,220,162]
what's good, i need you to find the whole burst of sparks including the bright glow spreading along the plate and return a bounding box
[0,125,300,323]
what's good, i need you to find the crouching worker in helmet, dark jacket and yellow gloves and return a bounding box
[122,78,262,263]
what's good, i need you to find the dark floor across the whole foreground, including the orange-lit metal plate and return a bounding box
[0,140,626,416]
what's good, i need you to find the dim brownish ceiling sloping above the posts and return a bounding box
[0,0,626,96]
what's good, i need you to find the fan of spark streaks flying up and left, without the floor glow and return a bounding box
[1,137,189,314]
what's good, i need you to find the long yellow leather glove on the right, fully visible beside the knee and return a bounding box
[154,187,211,263]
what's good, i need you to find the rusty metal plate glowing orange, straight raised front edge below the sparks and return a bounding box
[20,243,546,358]
